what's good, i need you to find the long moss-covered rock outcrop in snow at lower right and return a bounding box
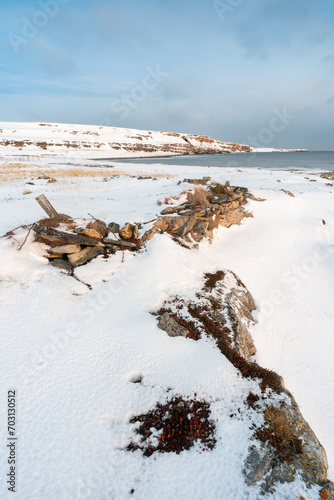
[157,271,334,500]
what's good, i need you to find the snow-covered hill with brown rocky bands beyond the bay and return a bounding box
[0,122,306,159]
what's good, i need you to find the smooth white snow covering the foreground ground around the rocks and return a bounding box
[0,157,334,500]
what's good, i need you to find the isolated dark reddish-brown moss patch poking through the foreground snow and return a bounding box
[127,396,216,457]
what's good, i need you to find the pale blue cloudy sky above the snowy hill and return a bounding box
[0,0,334,151]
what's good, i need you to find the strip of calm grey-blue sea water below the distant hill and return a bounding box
[114,151,334,170]
